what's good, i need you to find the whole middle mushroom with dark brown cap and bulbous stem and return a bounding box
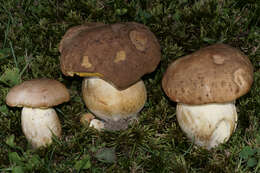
[59,22,161,130]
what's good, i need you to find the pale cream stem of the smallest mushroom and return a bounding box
[21,107,61,148]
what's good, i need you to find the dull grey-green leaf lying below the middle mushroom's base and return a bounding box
[95,148,116,163]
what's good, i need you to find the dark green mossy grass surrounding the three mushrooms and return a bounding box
[0,0,260,173]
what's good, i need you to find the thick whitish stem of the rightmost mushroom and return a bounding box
[177,102,237,149]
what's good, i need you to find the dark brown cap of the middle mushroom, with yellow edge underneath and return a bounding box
[59,22,161,89]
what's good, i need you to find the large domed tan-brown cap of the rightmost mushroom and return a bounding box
[162,44,253,105]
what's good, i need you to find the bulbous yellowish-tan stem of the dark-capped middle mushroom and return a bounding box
[82,78,147,130]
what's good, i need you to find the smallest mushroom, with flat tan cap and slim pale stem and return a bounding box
[6,78,70,148]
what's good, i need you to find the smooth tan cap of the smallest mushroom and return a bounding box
[6,78,70,108]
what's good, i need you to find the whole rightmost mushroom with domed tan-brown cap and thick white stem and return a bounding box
[162,44,253,149]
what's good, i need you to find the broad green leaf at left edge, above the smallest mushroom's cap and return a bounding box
[0,68,21,87]
